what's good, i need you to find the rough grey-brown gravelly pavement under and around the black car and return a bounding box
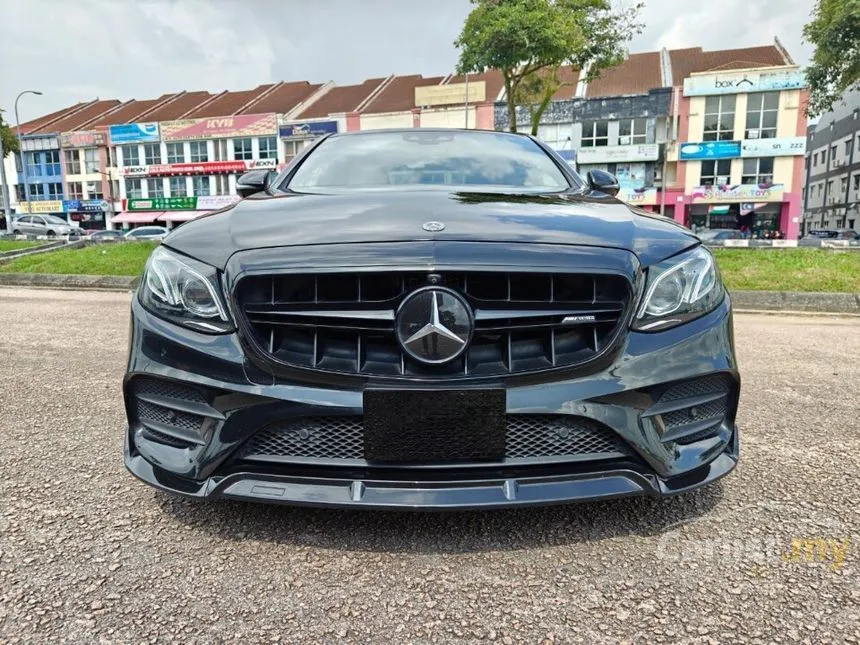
[0,289,860,643]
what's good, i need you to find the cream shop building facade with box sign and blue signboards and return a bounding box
[668,65,806,239]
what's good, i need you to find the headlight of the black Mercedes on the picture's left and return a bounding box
[139,246,233,334]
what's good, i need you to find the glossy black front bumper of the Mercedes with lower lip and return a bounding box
[124,298,740,509]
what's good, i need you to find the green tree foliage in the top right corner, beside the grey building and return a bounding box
[803,0,860,115]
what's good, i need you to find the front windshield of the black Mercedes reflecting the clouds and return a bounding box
[288,130,570,192]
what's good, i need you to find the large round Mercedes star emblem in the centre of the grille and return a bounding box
[397,287,474,365]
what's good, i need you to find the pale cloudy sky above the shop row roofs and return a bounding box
[0,0,814,122]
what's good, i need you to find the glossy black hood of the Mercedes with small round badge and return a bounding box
[164,190,699,268]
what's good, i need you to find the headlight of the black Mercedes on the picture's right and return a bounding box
[633,246,725,331]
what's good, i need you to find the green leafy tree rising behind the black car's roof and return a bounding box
[454,0,642,134]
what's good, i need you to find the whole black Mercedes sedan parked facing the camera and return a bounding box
[123,129,740,509]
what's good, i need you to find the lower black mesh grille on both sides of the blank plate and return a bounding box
[238,414,632,464]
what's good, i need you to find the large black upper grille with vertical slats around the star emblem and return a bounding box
[236,271,630,378]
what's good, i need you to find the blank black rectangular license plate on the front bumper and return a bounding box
[364,389,507,463]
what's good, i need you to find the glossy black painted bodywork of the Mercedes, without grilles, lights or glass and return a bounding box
[125,127,740,508]
